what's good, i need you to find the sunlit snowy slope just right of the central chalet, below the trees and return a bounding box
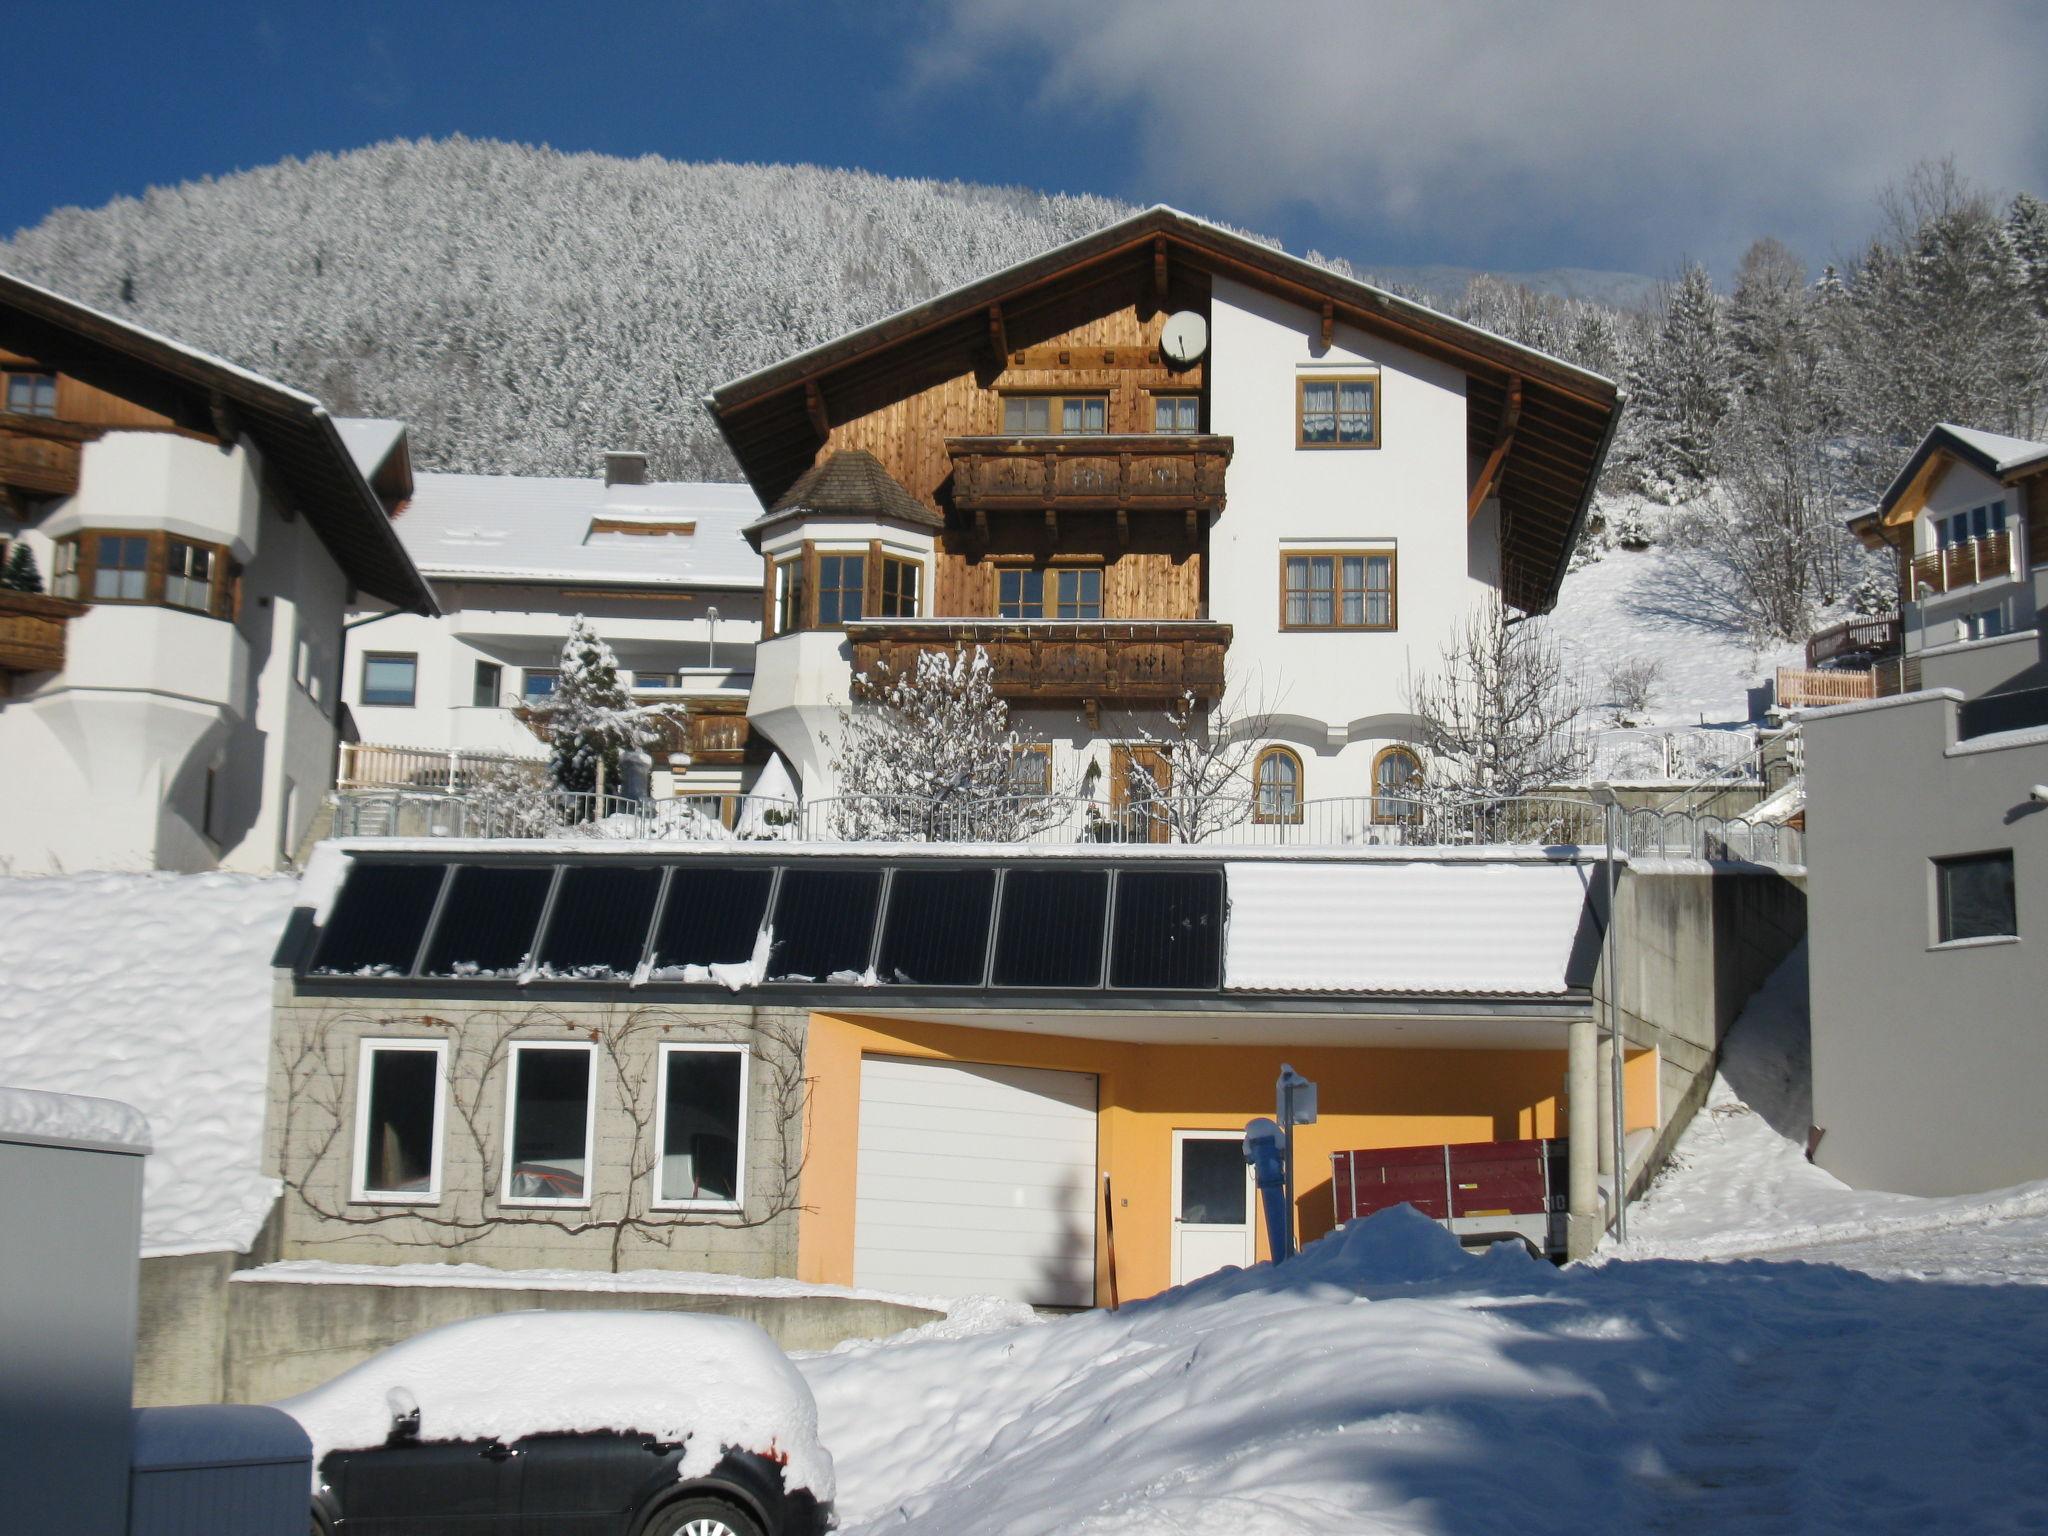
[1550,506,1804,725]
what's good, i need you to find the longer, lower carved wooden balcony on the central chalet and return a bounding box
[846,618,1231,705]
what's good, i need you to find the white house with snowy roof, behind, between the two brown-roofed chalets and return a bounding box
[342,448,762,795]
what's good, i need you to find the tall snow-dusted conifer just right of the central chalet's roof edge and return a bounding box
[1632,262,1735,502]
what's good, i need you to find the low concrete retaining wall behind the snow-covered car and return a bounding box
[221,1280,940,1403]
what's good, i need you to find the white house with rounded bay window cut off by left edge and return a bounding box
[0,274,434,872]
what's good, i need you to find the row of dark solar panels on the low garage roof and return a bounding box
[301,858,1225,991]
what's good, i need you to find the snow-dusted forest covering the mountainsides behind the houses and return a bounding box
[0,137,2048,639]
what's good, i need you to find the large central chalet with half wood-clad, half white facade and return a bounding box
[709,207,1620,817]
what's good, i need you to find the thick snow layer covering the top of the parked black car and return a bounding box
[276,1313,834,1499]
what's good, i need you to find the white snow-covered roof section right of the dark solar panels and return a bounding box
[1223,860,1595,995]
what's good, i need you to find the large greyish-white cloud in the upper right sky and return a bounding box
[918,0,2048,270]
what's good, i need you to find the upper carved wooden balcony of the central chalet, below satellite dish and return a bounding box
[946,434,1231,512]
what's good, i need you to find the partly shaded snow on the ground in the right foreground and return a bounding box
[801,952,2048,1536]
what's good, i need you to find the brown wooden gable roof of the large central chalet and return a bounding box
[705,205,1622,612]
